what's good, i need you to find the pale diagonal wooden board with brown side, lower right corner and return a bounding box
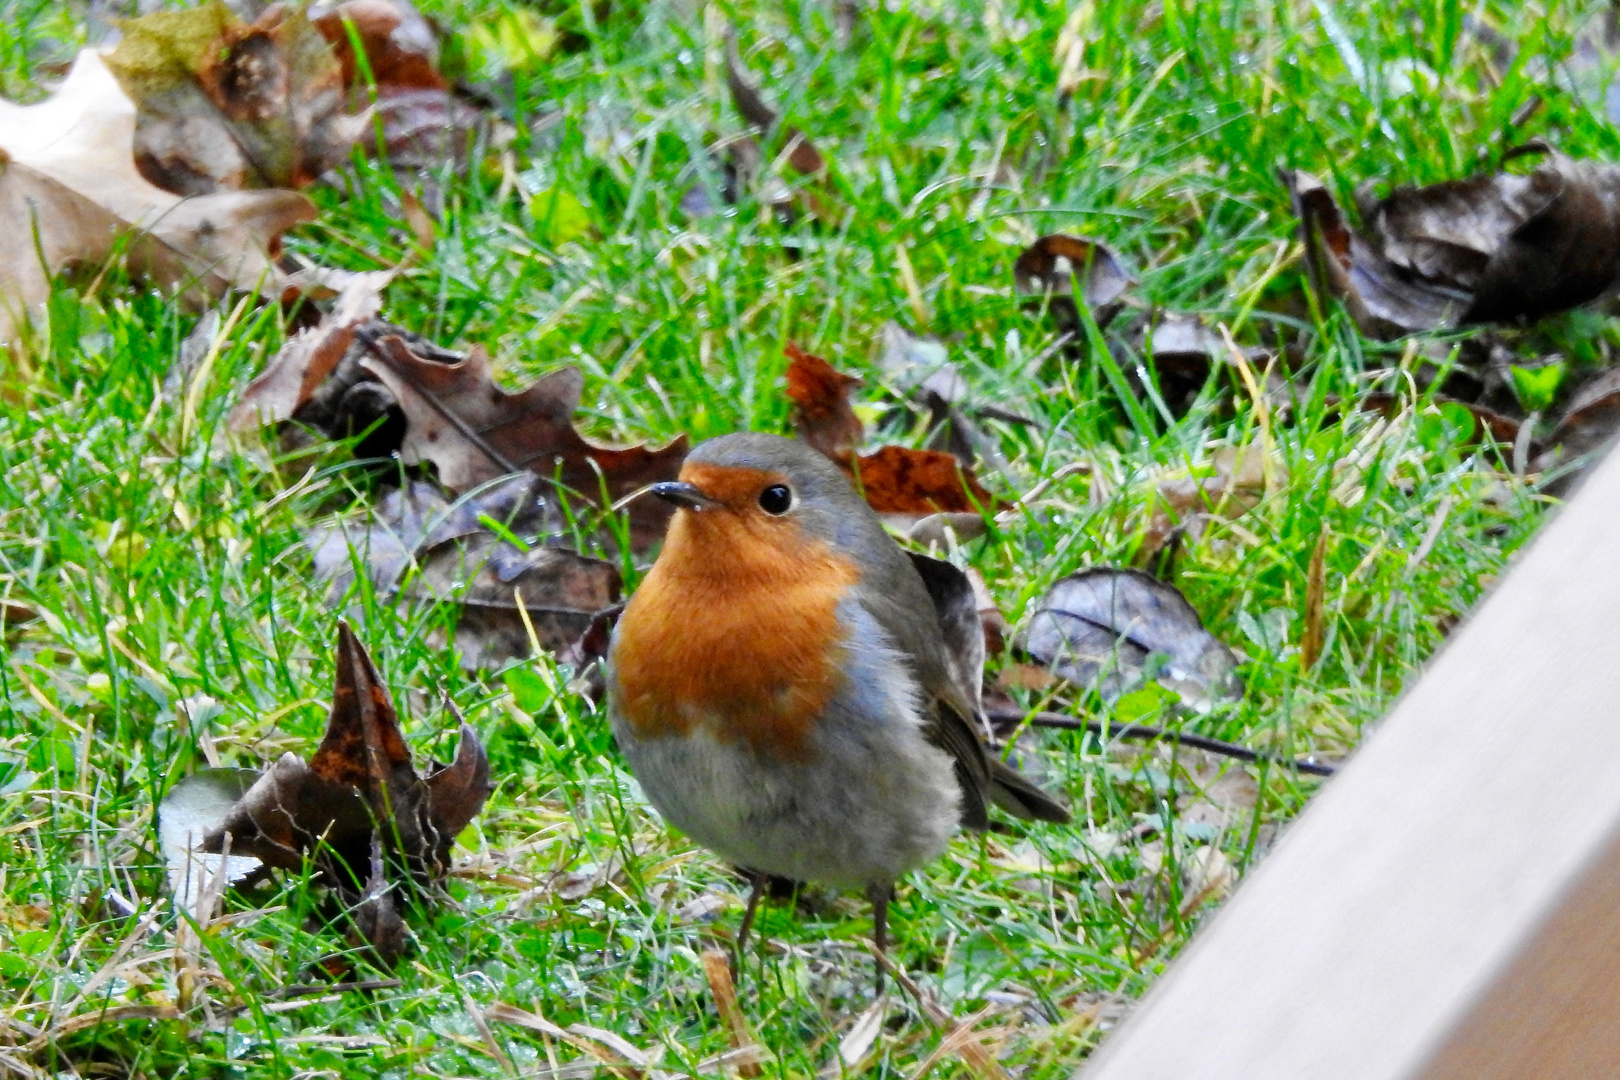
[1081,443,1620,1080]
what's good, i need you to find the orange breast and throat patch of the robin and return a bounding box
[609,472,860,758]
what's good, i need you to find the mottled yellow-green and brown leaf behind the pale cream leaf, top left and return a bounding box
[107,0,371,194]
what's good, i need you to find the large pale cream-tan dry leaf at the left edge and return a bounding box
[0,50,316,343]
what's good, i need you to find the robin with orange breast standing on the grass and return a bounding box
[608,434,1069,986]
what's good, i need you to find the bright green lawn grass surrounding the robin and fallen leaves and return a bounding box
[0,0,1617,1078]
